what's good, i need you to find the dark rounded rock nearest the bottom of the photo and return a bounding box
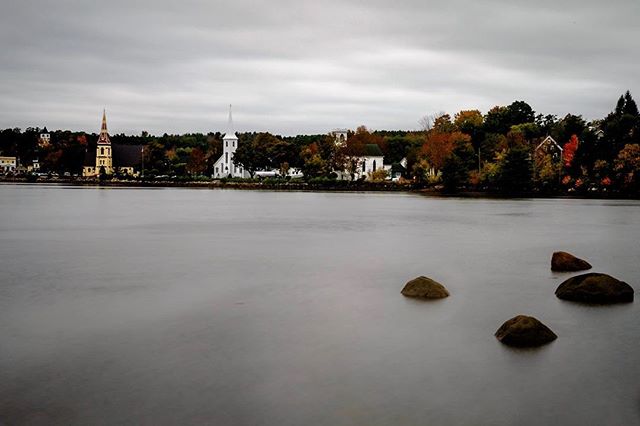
[496,315,558,347]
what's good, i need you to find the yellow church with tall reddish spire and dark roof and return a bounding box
[82,111,142,177]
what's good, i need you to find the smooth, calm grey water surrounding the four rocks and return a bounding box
[0,185,640,425]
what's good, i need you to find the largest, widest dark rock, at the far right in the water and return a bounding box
[556,272,633,304]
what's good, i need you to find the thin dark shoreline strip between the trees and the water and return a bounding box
[0,177,640,200]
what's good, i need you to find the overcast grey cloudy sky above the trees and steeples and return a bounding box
[0,0,640,135]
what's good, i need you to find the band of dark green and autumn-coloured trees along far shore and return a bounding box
[0,91,640,194]
